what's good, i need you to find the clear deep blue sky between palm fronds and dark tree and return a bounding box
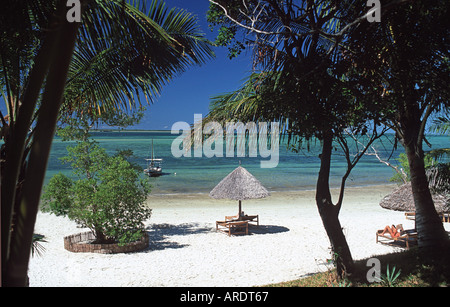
[131,0,252,130]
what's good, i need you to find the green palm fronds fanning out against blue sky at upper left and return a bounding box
[61,0,214,119]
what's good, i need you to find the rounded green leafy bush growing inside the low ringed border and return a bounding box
[42,141,151,244]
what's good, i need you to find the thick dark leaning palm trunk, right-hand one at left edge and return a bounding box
[2,10,79,286]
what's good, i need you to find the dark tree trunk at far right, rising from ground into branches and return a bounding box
[392,14,448,252]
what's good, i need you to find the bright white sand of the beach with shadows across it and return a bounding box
[29,185,428,287]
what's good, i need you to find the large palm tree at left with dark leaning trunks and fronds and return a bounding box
[0,0,213,286]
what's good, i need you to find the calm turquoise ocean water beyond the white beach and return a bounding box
[46,131,450,194]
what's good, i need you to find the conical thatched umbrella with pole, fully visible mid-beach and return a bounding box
[209,166,270,216]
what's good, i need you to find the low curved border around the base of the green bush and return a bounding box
[64,231,149,254]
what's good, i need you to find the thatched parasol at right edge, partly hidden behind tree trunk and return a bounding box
[380,182,450,213]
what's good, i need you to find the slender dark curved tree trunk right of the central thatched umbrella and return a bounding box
[316,133,353,279]
